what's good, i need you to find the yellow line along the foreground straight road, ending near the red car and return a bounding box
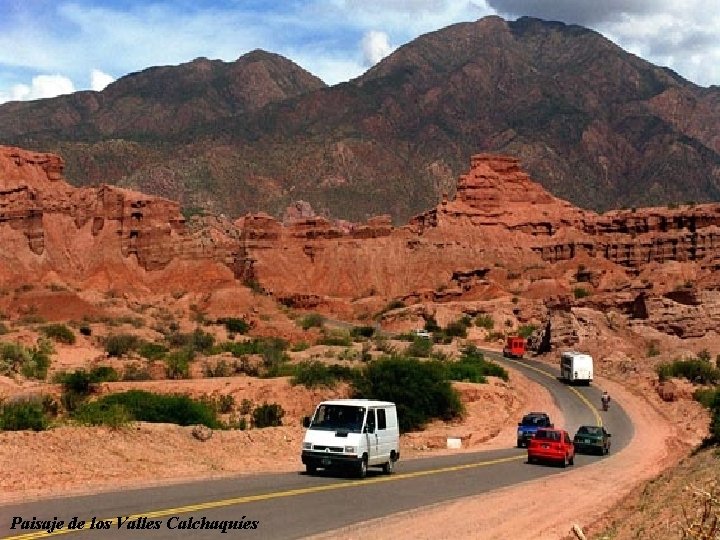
[5,452,525,540]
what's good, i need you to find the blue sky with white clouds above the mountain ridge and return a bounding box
[0,0,720,103]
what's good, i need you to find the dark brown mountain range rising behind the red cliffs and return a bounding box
[0,17,720,223]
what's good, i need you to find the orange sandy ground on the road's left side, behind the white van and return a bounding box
[0,364,562,504]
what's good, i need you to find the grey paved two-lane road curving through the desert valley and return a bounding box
[0,354,633,540]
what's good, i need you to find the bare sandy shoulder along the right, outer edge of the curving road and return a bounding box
[313,380,685,540]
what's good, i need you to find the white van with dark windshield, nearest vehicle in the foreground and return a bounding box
[302,399,400,478]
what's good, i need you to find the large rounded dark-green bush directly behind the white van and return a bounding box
[353,356,463,432]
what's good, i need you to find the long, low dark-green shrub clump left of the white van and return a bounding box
[73,390,221,428]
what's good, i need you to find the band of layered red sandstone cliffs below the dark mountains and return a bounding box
[0,147,720,342]
